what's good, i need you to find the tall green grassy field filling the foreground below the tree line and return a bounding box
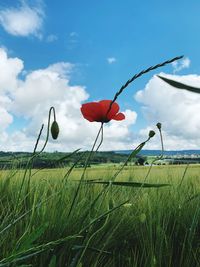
[0,165,200,267]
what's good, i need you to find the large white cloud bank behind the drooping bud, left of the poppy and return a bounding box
[0,49,137,151]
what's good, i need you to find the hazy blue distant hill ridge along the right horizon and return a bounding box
[114,149,200,156]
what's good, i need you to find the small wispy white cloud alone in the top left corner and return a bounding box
[0,1,44,38]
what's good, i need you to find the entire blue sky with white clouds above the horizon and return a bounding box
[0,0,200,151]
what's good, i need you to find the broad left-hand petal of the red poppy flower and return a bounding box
[81,102,102,122]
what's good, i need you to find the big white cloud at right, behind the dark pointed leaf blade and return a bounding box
[135,73,200,149]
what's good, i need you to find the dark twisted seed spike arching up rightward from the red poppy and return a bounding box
[107,56,183,114]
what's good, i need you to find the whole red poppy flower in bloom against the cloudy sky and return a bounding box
[81,100,125,123]
